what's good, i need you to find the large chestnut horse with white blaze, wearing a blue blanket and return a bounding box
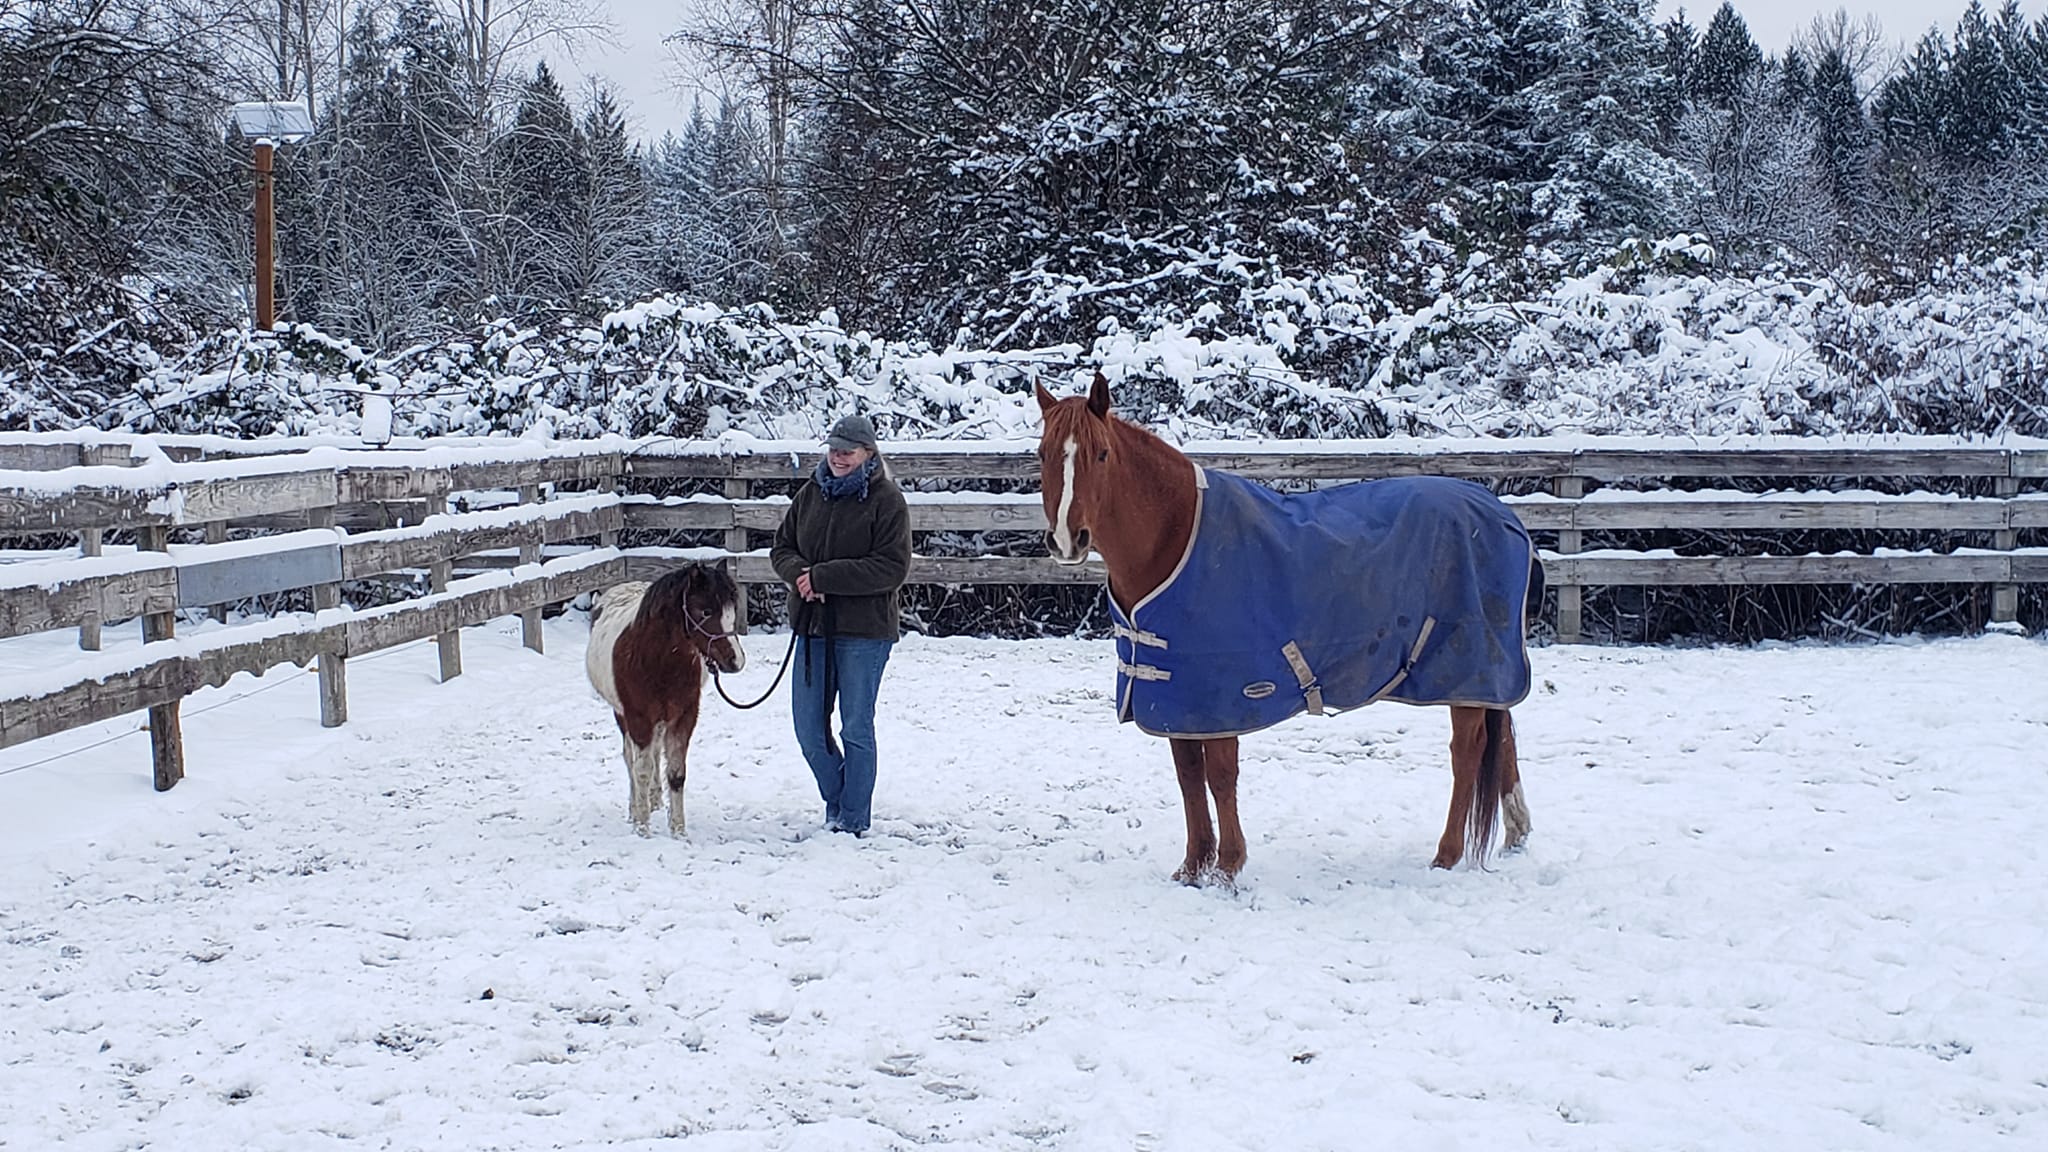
[1036,373,1542,883]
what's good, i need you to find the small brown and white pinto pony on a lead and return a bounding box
[584,564,745,836]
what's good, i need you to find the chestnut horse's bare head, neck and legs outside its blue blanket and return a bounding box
[1036,373,1540,883]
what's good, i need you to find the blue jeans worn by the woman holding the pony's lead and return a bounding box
[788,635,895,832]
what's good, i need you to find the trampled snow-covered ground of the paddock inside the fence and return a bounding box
[0,617,2048,1152]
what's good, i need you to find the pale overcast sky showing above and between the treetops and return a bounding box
[565,0,2048,137]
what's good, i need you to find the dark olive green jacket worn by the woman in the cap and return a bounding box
[768,467,909,640]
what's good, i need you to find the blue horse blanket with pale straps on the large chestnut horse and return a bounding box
[1110,469,1536,738]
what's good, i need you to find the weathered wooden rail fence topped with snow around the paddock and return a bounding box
[0,433,2048,787]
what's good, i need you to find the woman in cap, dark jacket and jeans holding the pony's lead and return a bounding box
[770,416,909,836]
